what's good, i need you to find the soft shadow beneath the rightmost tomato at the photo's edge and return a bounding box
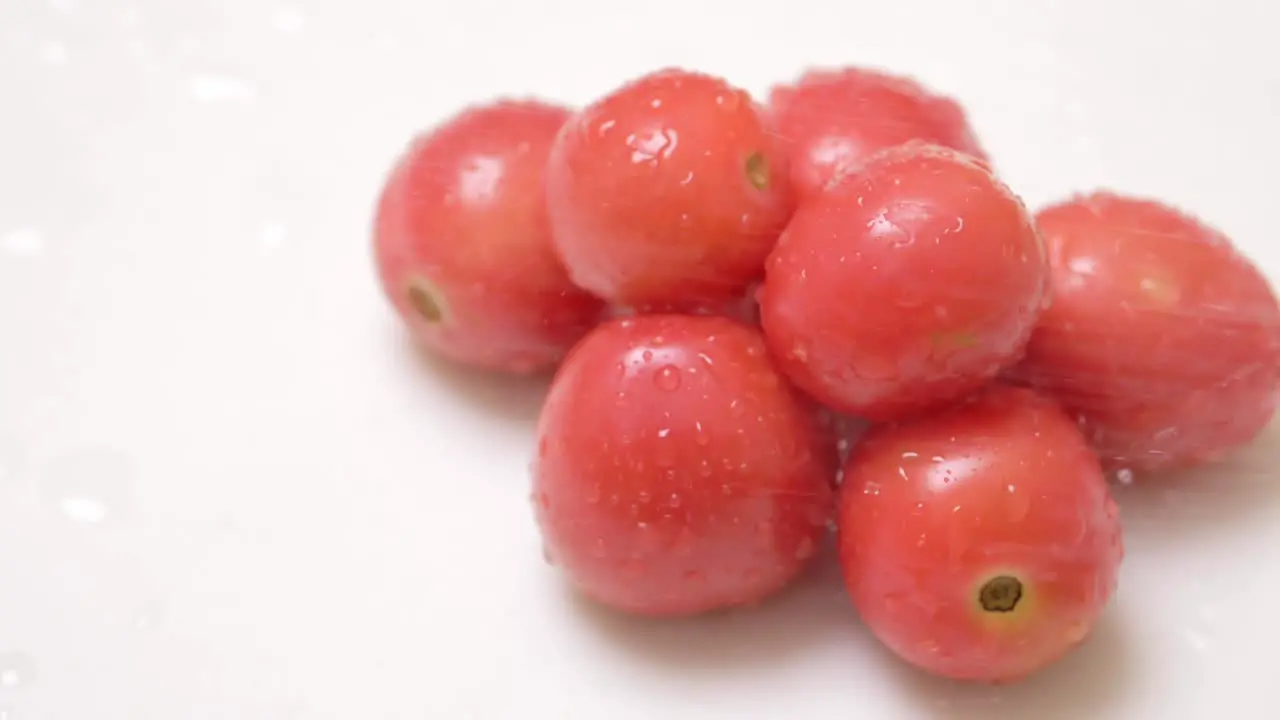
[1114,421,1280,542]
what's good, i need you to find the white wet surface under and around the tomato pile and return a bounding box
[0,0,1280,720]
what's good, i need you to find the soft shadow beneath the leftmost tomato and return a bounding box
[392,320,552,425]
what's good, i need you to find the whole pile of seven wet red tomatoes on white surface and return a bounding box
[374,68,1280,682]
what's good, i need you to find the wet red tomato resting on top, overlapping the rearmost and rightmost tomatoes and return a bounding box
[760,143,1048,420]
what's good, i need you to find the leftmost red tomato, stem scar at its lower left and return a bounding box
[374,101,603,373]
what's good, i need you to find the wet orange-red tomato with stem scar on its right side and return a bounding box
[547,70,791,310]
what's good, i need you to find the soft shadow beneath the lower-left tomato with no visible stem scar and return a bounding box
[566,540,865,676]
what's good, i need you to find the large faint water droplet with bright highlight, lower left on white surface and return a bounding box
[41,448,133,525]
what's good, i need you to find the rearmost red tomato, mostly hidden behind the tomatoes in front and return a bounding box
[769,68,987,199]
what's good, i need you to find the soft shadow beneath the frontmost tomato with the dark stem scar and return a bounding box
[881,607,1133,720]
